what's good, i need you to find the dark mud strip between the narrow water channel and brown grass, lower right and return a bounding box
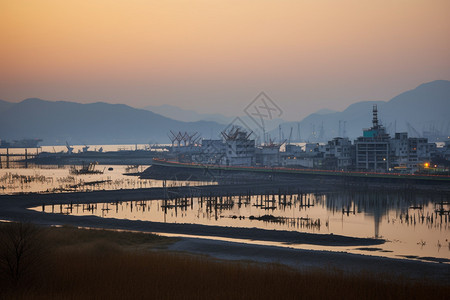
[169,238,450,285]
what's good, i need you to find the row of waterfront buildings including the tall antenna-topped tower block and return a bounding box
[166,105,442,173]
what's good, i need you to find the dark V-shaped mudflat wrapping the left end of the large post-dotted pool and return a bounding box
[0,183,384,246]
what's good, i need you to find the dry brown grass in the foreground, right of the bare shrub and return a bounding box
[0,224,450,299]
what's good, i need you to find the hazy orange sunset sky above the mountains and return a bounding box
[0,0,450,120]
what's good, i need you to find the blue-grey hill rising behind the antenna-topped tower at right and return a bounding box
[270,80,450,142]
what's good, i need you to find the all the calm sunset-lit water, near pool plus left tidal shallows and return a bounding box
[0,145,450,260]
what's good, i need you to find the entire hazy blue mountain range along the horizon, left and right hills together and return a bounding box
[0,80,450,145]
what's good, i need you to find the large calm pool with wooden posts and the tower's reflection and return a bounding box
[34,192,450,262]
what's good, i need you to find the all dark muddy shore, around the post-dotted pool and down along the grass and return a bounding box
[0,182,450,284]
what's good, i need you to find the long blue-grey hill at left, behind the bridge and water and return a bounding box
[0,98,224,144]
